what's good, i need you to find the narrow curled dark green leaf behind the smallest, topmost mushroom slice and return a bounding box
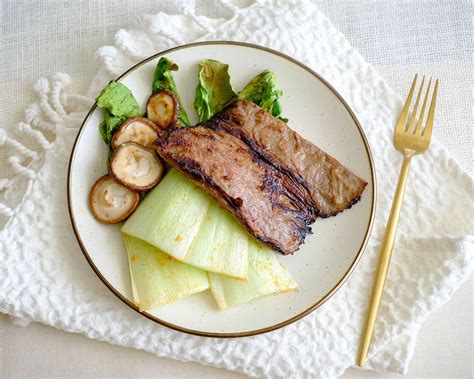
[151,57,190,126]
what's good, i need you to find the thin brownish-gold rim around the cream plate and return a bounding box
[67,41,377,338]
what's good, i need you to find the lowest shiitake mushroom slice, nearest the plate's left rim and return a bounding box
[89,175,140,224]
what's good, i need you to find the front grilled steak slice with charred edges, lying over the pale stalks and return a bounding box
[155,126,315,254]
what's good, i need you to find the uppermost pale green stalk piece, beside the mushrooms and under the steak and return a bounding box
[121,170,211,261]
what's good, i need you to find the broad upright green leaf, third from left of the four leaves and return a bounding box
[194,59,237,122]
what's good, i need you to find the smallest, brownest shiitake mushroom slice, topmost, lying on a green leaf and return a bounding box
[146,90,179,129]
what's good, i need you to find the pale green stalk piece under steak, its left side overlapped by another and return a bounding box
[185,202,248,279]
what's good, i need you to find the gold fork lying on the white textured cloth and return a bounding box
[357,75,438,366]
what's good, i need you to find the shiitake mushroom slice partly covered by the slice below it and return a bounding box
[112,117,160,150]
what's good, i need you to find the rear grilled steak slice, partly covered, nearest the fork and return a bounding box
[203,100,367,217]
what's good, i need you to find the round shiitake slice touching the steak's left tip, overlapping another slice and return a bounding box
[110,142,164,192]
